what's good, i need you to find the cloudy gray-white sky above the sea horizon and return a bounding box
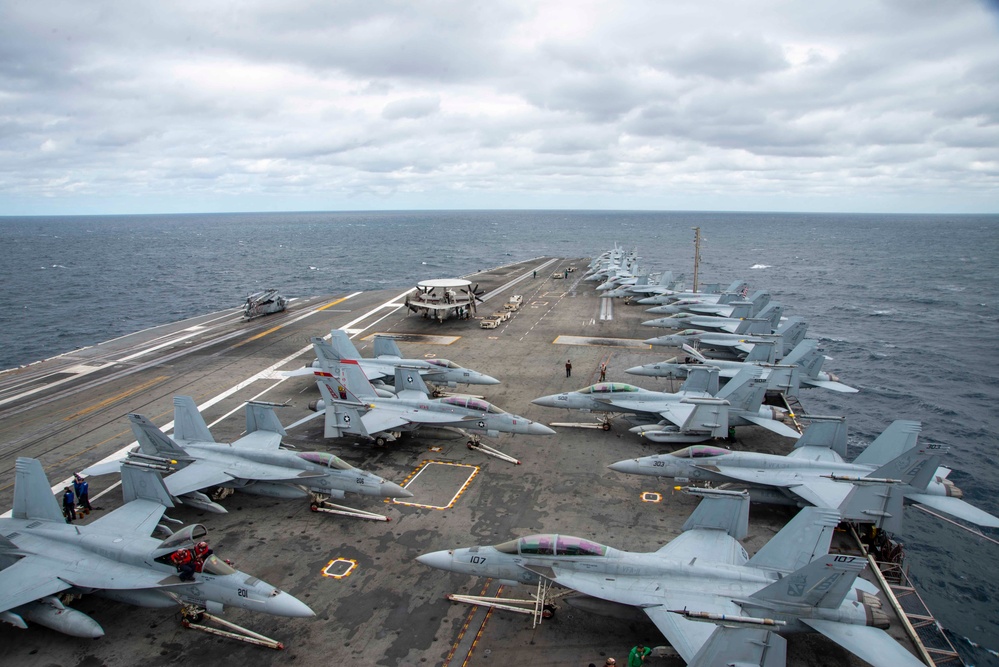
[0,0,999,215]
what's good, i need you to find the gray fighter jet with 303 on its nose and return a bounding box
[609,420,999,530]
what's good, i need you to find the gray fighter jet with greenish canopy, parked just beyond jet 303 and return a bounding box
[531,367,800,442]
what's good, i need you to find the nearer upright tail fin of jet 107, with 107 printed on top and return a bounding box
[750,554,867,609]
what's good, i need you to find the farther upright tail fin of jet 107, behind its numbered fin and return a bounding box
[749,507,840,572]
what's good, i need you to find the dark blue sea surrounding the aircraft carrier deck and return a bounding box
[0,211,999,665]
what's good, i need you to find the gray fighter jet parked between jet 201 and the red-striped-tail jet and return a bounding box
[84,396,413,513]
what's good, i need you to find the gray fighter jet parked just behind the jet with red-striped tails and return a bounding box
[294,329,499,388]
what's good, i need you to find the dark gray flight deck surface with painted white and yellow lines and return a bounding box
[0,258,920,667]
